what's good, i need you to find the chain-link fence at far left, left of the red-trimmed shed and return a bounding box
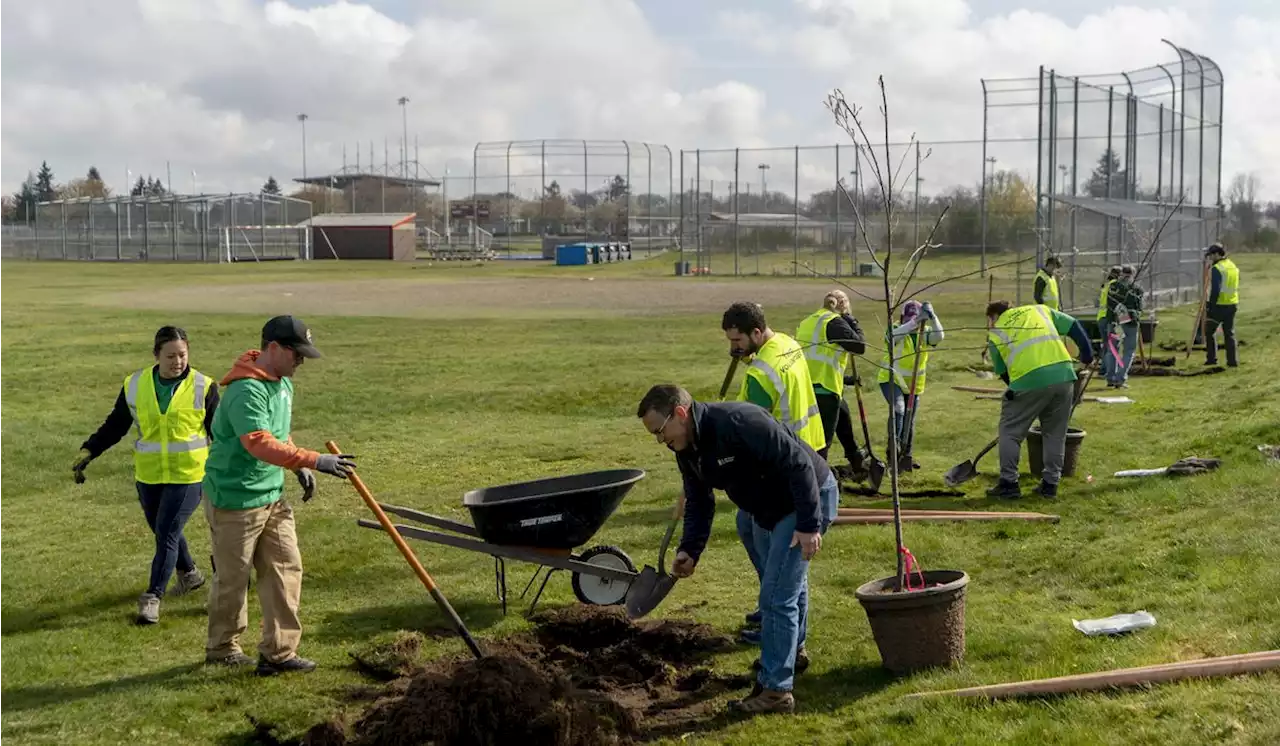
[0,194,311,262]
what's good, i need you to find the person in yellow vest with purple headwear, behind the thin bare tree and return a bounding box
[876,301,945,471]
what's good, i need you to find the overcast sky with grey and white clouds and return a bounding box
[0,0,1280,201]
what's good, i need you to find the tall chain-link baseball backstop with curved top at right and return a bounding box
[982,41,1224,311]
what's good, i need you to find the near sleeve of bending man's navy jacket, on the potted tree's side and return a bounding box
[728,412,820,534]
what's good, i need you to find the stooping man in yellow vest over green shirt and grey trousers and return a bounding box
[987,301,1093,499]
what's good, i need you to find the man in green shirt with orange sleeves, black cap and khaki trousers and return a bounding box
[204,316,355,676]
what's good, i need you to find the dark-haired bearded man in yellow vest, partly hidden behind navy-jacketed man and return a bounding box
[721,302,840,642]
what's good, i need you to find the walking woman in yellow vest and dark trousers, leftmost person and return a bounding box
[73,326,218,624]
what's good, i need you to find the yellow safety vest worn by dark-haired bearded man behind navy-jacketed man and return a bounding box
[739,331,827,450]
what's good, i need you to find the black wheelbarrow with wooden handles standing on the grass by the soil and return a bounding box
[357,468,645,614]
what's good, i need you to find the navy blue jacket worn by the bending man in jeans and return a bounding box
[676,402,831,560]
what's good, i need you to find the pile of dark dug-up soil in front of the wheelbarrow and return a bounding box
[303,605,750,746]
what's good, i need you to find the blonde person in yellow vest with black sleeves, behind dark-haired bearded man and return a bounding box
[796,290,867,475]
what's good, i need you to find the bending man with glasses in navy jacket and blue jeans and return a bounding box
[636,384,840,713]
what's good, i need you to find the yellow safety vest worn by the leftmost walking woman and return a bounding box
[124,367,211,485]
